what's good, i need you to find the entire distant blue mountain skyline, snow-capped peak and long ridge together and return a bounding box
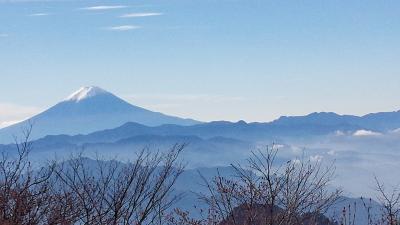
[0,86,400,144]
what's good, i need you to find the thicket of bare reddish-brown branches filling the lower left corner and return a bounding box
[0,126,185,225]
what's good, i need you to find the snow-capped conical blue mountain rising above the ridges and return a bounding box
[0,86,200,143]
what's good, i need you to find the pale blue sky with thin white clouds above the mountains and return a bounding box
[0,0,400,126]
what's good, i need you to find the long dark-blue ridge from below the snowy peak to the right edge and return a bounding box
[0,109,400,143]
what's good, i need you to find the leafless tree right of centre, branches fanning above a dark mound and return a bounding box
[171,146,341,225]
